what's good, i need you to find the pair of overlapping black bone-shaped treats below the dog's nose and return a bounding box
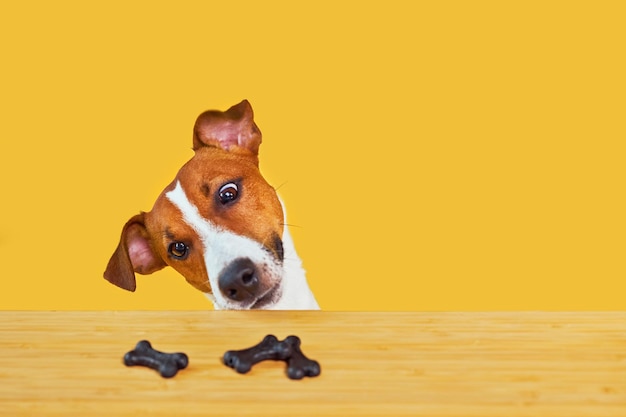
[223,334,321,379]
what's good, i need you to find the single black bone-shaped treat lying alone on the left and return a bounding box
[124,340,189,378]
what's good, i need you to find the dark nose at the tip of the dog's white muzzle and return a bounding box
[217,258,259,301]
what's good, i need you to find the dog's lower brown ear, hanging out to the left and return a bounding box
[104,213,166,291]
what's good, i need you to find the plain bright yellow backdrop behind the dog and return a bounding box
[0,0,626,310]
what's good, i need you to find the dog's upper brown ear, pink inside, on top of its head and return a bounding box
[193,100,261,155]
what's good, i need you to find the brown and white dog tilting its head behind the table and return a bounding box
[104,100,319,310]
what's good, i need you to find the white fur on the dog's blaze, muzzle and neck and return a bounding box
[166,182,319,310]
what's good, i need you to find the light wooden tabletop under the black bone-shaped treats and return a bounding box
[0,311,626,417]
